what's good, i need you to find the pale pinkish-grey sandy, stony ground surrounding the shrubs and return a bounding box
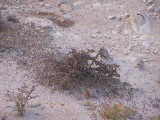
[0,0,160,120]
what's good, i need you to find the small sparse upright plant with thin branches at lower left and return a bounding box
[7,83,37,115]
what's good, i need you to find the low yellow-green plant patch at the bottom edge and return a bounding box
[99,104,135,120]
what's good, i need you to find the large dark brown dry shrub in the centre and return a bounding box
[36,49,120,90]
